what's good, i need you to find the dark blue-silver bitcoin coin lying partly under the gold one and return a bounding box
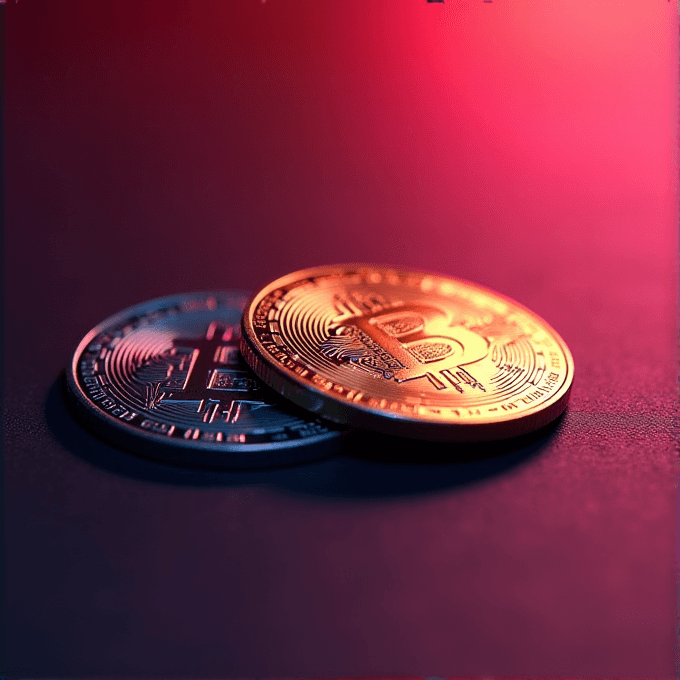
[66,291,342,468]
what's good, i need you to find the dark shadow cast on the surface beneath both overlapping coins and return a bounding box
[44,373,561,501]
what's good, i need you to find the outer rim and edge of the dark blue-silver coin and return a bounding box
[65,289,345,468]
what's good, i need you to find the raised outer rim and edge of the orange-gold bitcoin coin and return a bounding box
[241,263,574,442]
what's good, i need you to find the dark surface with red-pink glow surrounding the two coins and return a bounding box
[0,0,678,678]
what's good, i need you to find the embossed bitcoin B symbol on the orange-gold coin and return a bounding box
[320,303,489,393]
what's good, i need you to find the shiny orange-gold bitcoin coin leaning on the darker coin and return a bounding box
[241,264,574,441]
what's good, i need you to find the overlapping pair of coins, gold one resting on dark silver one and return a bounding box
[67,264,574,468]
